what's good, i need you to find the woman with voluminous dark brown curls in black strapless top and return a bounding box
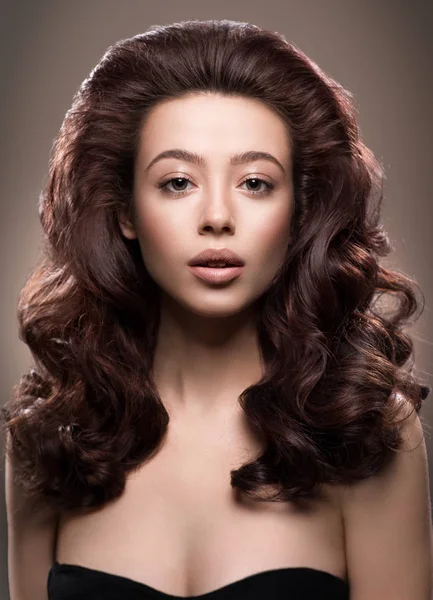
[3,20,431,600]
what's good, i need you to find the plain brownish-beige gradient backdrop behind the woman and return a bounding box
[0,0,433,600]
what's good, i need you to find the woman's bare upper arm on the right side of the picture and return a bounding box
[342,412,433,600]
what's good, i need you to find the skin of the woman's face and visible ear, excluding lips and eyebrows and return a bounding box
[120,93,293,317]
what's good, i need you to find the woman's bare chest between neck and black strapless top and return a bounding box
[56,412,345,595]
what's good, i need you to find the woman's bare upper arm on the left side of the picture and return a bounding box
[5,432,57,600]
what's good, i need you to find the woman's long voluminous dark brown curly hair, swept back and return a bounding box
[2,20,430,510]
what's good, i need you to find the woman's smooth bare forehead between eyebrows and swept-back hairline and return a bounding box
[140,93,290,161]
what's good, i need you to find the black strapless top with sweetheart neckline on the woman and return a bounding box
[47,561,349,600]
